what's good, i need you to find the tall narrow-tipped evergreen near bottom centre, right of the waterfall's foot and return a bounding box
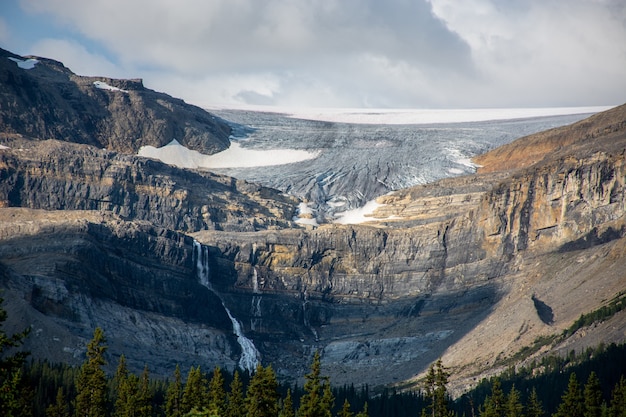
[298,351,335,417]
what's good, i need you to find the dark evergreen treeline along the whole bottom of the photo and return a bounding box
[0,300,626,417]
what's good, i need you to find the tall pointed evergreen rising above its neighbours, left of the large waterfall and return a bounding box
[75,327,107,417]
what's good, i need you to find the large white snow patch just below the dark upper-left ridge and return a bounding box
[138,139,319,169]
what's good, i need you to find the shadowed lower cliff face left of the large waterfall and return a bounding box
[0,208,238,375]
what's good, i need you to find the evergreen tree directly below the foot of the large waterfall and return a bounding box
[245,364,280,417]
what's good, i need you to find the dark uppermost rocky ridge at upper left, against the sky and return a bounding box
[0,49,230,154]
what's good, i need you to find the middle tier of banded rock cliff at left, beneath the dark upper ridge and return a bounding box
[0,139,297,231]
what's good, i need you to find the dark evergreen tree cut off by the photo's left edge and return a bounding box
[0,298,32,417]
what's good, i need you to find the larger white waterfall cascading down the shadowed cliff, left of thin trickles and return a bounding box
[193,240,259,373]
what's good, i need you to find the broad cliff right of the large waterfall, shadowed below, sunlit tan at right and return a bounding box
[195,106,626,383]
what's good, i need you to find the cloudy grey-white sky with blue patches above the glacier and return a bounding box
[0,0,626,109]
